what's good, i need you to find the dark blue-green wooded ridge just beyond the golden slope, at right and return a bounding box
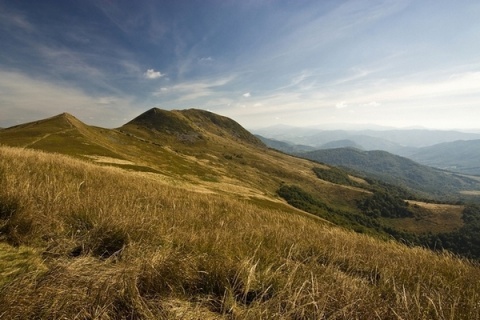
[299,148,480,199]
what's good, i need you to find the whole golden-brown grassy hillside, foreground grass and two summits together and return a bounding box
[0,109,480,319]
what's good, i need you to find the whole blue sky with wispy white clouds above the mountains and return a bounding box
[0,0,480,130]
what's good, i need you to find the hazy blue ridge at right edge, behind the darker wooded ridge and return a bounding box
[406,140,480,176]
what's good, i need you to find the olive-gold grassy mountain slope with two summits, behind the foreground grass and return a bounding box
[0,109,363,210]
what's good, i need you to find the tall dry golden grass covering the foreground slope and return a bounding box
[0,147,480,319]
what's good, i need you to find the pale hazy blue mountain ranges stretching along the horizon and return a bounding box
[256,127,480,175]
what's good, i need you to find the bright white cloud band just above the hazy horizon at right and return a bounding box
[224,65,480,128]
